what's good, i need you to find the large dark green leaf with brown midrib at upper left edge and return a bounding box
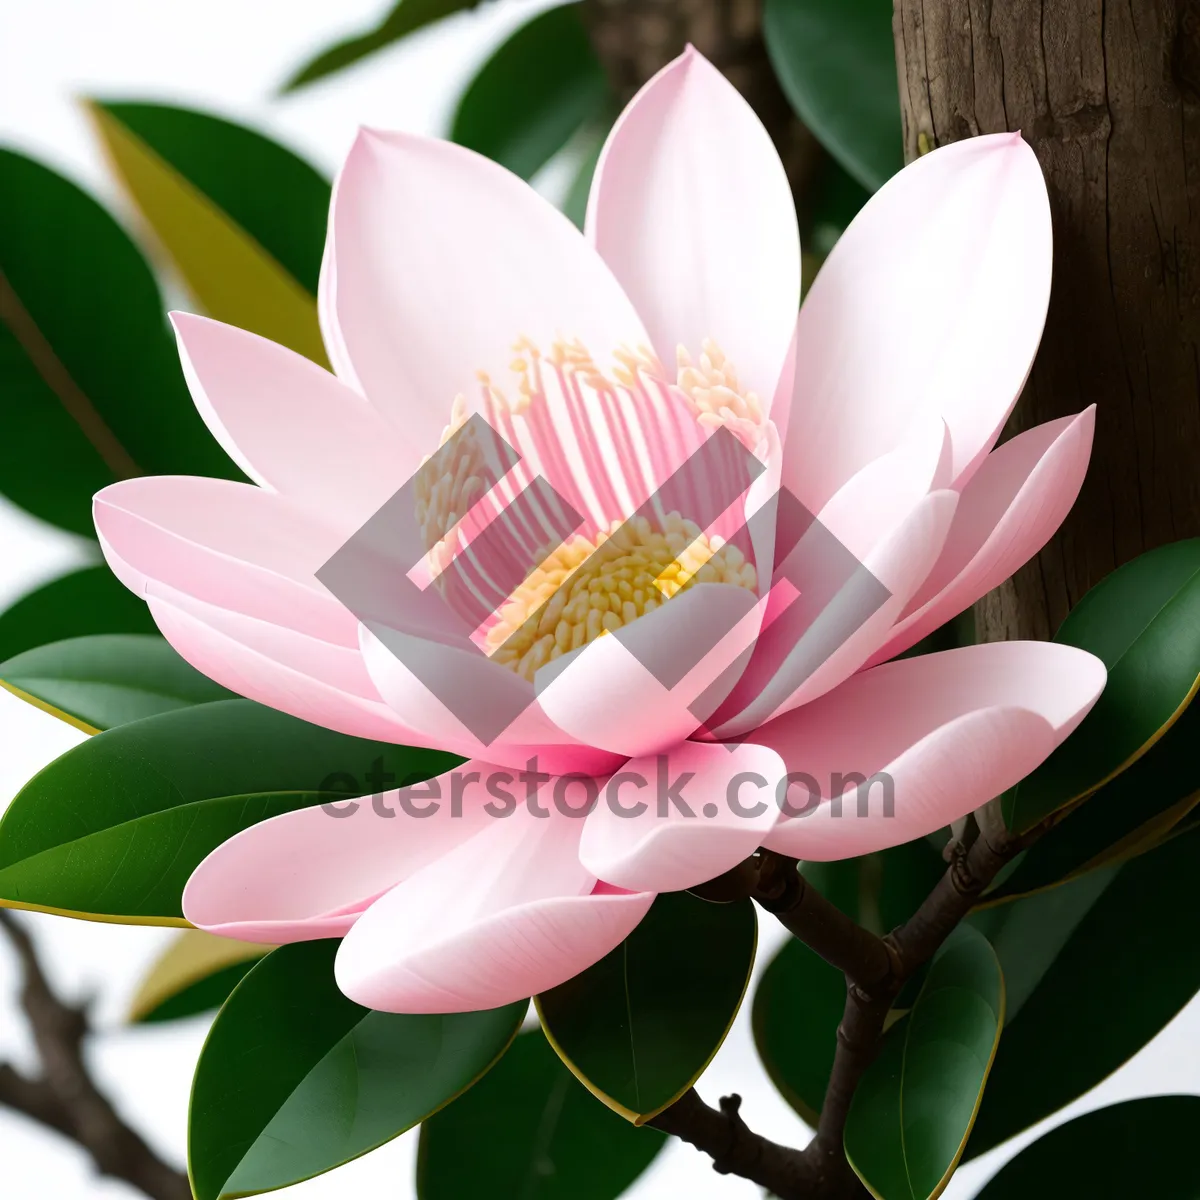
[0,150,238,536]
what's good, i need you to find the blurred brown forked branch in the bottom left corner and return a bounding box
[0,908,192,1200]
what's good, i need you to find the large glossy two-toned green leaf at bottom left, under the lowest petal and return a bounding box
[187,941,527,1200]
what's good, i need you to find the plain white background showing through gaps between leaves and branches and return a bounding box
[0,0,1200,1200]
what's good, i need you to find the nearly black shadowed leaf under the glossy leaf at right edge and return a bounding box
[988,702,1200,901]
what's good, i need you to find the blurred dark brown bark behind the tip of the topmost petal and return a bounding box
[582,0,822,199]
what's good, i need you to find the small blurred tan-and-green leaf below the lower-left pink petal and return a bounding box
[128,929,269,1024]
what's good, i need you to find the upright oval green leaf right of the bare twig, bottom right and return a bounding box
[845,925,1004,1200]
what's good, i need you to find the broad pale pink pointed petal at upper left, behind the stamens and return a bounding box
[322,130,646,452]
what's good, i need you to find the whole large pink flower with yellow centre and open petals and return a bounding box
[96,52,1104,1012]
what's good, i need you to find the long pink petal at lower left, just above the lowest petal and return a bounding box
[184,762,493,944]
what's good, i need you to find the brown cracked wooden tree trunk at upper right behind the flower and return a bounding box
[894,0,1200,640]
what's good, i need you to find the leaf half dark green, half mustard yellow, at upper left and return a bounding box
[89,101,330,365]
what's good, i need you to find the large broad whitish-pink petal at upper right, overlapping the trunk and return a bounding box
[784,133,1051,510]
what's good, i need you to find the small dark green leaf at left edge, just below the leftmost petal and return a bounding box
[0,565,157,661]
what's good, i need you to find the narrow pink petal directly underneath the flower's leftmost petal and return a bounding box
[146,584,424,750]
